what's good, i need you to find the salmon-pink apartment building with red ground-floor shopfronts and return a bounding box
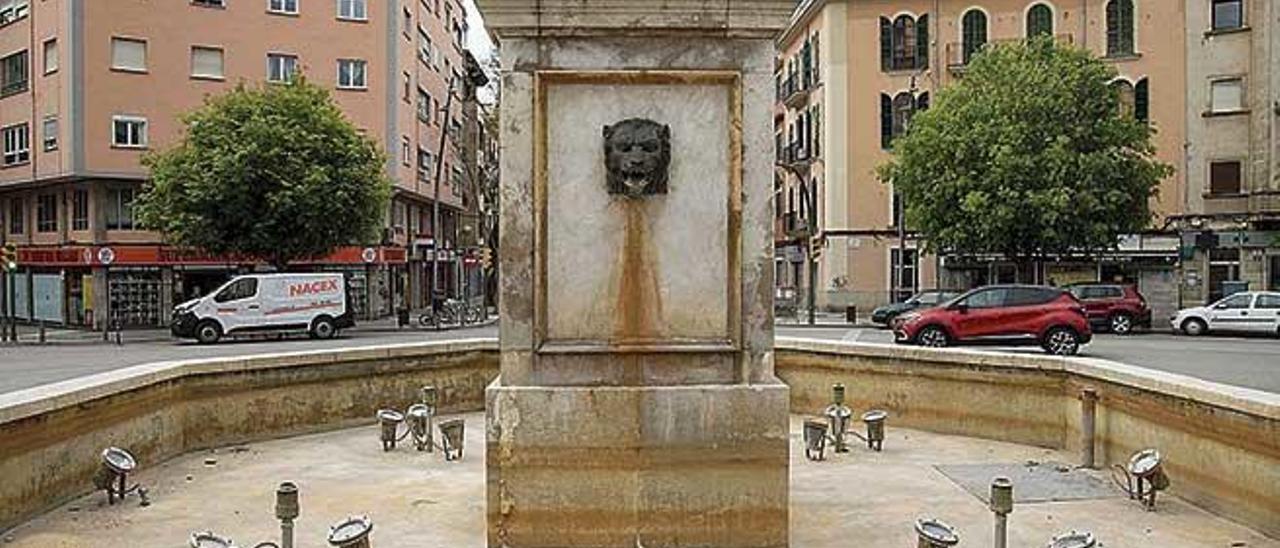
[0,0,488,325]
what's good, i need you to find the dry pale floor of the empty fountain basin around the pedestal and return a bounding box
[0,414,1280,548]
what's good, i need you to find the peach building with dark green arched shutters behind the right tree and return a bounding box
[774,0,1187,318]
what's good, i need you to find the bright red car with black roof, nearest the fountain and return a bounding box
[893,286,1093,356]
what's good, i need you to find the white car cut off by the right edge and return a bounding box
[1170,291,1280,335]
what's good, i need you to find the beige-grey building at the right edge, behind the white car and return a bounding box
[1175,0,1280,303]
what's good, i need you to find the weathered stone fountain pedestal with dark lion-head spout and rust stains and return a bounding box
[477,0,794,548]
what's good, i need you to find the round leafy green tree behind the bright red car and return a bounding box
[878,37,1172,261]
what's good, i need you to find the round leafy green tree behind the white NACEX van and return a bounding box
[137,77,390,269]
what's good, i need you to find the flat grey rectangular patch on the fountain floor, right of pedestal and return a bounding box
[934,461,1120,503]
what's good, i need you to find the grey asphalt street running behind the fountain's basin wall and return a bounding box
[0,325,1280,393]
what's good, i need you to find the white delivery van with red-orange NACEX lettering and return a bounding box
[170,273,356,344]
